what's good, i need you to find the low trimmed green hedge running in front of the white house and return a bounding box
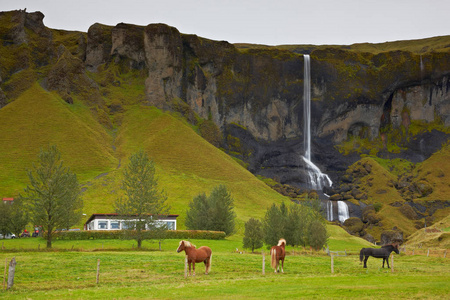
[53,230,225,240]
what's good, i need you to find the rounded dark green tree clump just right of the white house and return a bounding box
[185,185,236,235]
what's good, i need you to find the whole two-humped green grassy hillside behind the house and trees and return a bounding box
[0,84,289,231]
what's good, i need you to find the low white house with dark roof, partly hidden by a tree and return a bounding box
[84,214,178,230]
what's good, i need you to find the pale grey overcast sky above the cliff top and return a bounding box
[0,0,450,45]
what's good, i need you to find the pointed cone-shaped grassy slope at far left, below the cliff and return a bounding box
[0,84,117,197]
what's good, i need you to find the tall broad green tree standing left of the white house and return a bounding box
[19,146,83,248]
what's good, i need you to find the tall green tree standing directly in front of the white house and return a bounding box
[115,151,169,248]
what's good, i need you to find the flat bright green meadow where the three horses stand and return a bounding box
[0,236,450,299]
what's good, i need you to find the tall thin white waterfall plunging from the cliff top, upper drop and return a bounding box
[303,54,333,190]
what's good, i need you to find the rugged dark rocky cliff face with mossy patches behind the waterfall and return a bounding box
[0,11,450,186]
